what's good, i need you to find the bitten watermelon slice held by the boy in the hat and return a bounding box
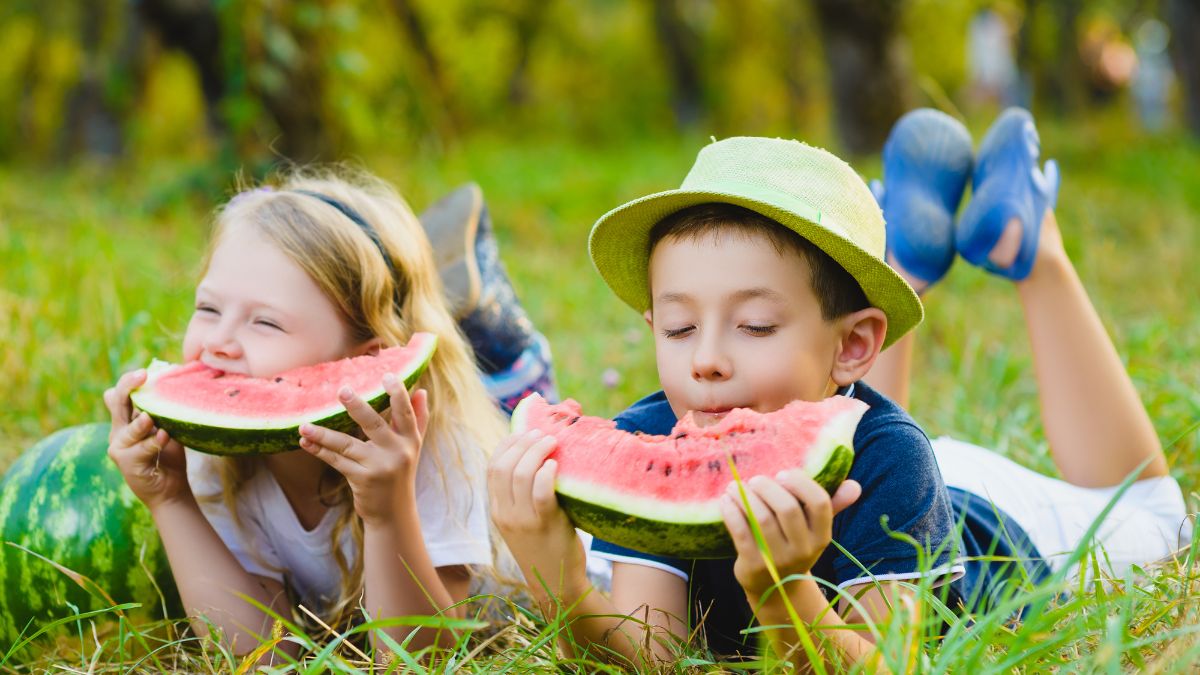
[512,394,868,558]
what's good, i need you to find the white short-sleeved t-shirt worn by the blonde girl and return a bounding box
[187,429,492,614]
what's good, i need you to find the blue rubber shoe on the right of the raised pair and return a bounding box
[955,108,1058,281]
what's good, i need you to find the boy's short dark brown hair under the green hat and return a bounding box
[649,202,871,321]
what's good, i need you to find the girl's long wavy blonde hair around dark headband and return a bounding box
[204,168,506,625]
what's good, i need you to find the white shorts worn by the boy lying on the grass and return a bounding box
[932,437,1192,577]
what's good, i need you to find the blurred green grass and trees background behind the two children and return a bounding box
[0,0,1200,489]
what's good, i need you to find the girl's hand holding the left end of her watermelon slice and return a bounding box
[104,370,192,510]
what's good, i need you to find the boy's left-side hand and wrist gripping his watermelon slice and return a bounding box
[487,430,588,602]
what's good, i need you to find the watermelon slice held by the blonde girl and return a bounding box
[130,333,438,455]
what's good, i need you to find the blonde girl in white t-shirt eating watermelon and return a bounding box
[104,166,505,652]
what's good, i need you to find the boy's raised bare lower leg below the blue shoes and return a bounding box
[991,210,1168,488]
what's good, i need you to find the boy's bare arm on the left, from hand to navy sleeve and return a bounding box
[487,431,686,664]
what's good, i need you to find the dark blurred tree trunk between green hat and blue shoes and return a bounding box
[814,0,911,155]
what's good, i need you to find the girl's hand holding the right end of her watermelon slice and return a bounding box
[300,375,430,525]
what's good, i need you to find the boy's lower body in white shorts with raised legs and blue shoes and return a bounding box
[868,108,1192,607]
